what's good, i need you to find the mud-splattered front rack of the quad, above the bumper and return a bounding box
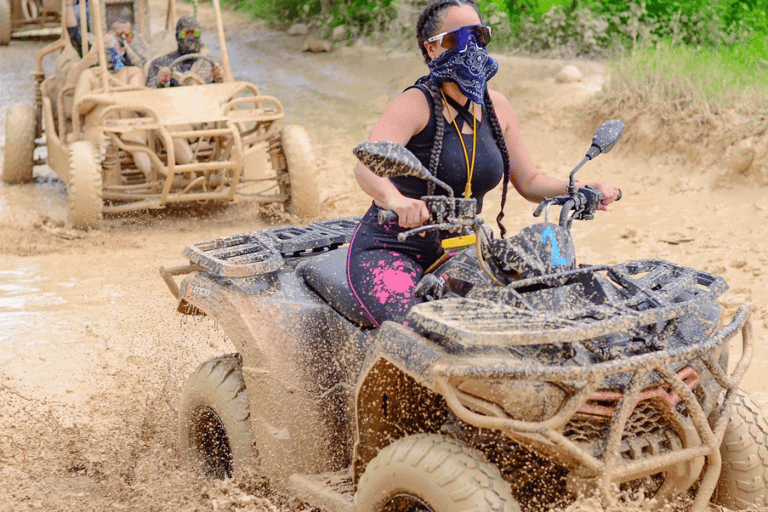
[408,260,728,347]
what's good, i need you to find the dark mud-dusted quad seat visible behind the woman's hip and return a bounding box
[296,247,375,328]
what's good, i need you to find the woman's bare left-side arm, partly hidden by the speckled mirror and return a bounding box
[355,89,429,228]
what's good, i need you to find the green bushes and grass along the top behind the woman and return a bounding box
[230,0,768,113]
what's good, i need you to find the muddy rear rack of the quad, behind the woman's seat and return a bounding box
[183,217,360,278]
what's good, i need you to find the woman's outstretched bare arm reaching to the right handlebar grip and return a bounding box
[490,91,619,209]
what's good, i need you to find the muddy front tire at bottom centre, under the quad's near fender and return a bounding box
[355,434,520,512]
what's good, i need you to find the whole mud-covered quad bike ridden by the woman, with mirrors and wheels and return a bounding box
[160,121,768,512]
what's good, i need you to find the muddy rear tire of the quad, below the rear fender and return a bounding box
[178,354,256,479]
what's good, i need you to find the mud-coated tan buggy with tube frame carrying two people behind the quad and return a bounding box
[0,0,319,228]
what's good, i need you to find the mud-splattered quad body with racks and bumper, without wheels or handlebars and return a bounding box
[159,214,750,510]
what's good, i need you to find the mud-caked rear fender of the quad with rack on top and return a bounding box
[163,219,372,480]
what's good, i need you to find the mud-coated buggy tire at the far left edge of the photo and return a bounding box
[0,105,37,185]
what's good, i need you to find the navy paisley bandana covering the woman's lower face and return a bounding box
[427,36,499,105]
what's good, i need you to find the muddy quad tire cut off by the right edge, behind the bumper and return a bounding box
[712,391,768,510]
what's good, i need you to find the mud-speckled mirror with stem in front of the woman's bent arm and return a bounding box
[352,140,453,197]
